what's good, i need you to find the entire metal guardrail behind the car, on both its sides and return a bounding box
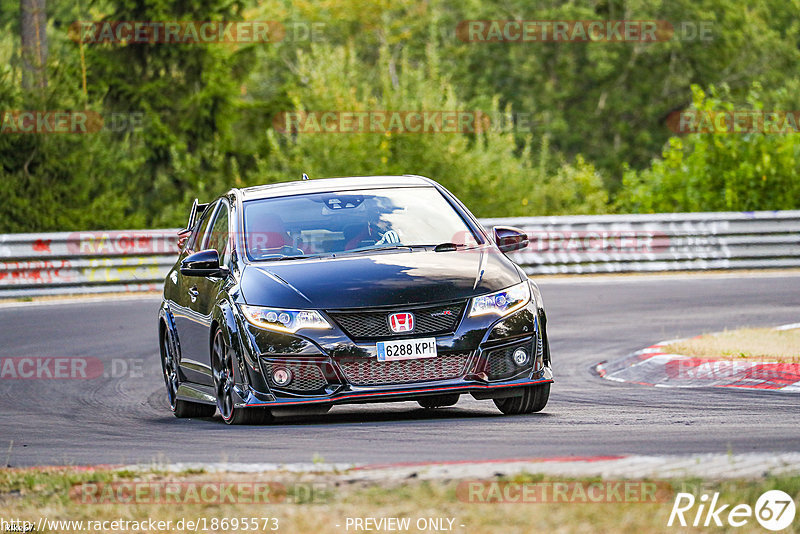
[0,211,800,298]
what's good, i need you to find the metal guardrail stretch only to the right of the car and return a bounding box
[481,211,800,274]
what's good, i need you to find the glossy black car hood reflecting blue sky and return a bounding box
[240,246,522,309]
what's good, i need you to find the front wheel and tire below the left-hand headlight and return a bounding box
[211,328,273,425]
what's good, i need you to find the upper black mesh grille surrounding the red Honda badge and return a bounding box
[328,302,465,339]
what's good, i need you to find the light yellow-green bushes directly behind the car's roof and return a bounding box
[251,45,606,217]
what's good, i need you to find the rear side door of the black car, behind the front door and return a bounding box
[170,203,218,384]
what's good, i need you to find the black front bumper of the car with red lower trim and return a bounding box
[231,306,553,408]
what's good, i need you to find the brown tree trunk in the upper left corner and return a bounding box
[19,0,47,89]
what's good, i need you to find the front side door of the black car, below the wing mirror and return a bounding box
[182,199,230,385]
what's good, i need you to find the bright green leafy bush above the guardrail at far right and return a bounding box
[617,85,800,213]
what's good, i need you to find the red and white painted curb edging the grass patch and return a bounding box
[595,323,800,393]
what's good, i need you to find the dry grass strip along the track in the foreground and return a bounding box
[0,468,800,534]
